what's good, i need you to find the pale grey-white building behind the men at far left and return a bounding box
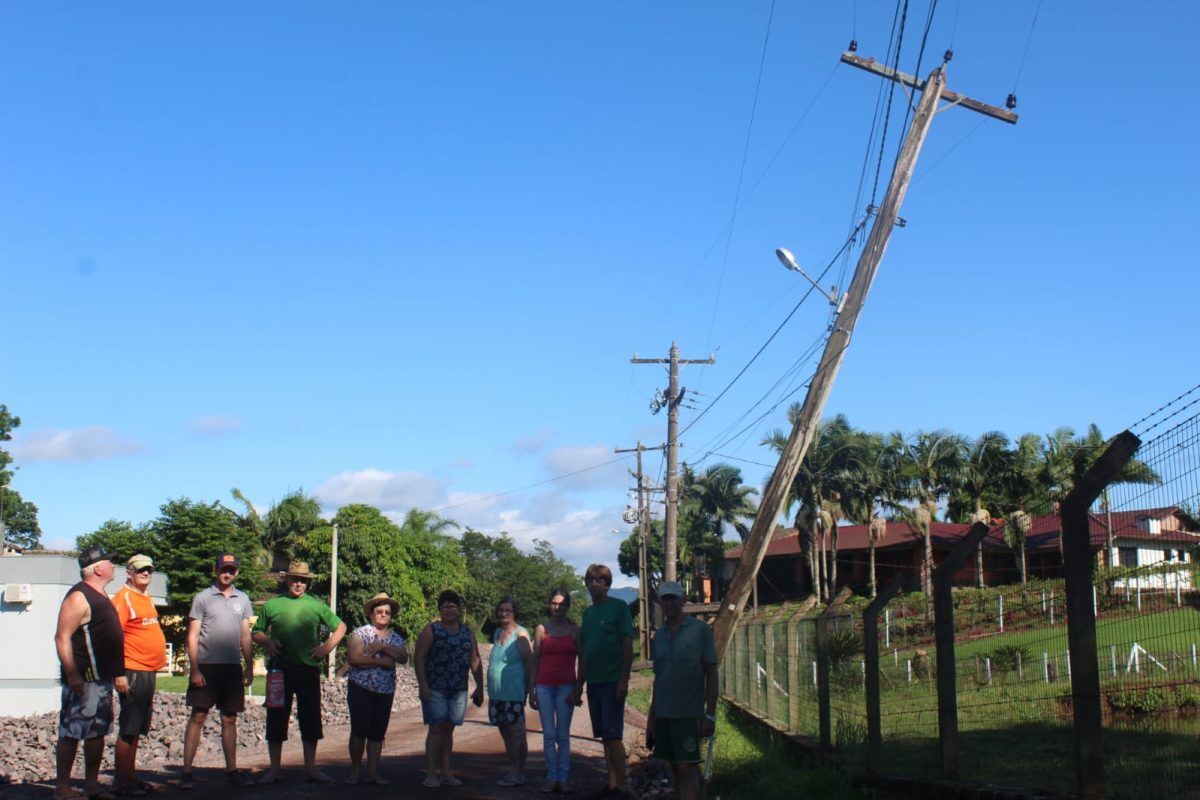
[0,555,167,716]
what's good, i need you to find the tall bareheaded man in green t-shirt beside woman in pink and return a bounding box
[578,564,634,794]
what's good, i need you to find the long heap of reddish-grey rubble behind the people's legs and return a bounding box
[0,668,419,784]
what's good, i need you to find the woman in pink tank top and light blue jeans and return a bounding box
[529,589,582,794]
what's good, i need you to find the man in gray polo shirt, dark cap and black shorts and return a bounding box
[179,553,254,789]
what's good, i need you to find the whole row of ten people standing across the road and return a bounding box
[54,547,718,800]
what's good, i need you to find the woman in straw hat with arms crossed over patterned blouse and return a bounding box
[346,591,408,786]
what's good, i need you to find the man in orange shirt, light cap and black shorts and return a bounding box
[113,555,167,796]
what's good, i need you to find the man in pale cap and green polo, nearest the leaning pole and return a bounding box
[646,581,718,800]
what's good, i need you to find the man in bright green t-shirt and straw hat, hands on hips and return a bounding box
[253,561,346,783]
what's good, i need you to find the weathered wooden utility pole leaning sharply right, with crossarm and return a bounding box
[713,52,1016,654]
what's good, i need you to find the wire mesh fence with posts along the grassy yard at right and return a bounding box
[721,398,1200,798]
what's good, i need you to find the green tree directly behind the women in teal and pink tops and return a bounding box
[461,528,584,631]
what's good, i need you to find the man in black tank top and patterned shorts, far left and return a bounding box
[54,546,128,800]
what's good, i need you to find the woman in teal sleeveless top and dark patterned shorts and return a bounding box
[487,597,533,786]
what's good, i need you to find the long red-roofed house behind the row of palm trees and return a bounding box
[722,507,1200,602]
